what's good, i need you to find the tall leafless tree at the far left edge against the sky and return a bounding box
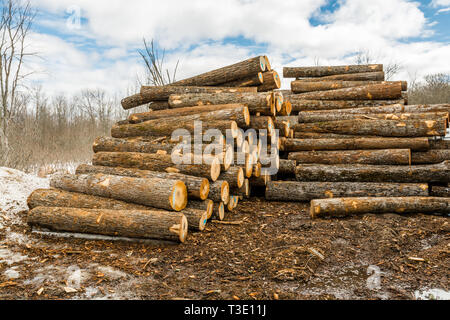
[0,0,35,159]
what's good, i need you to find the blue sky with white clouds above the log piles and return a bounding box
[22,0,450,95]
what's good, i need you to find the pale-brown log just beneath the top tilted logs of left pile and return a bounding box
[169,92,276,115]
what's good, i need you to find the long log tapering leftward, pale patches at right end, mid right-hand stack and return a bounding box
[292,119,447,137]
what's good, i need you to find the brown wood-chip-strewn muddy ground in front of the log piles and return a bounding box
[0,198,450,299]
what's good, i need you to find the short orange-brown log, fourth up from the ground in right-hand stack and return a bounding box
[288,149,411,165]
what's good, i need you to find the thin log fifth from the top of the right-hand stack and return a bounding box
[286,95,405,114]
